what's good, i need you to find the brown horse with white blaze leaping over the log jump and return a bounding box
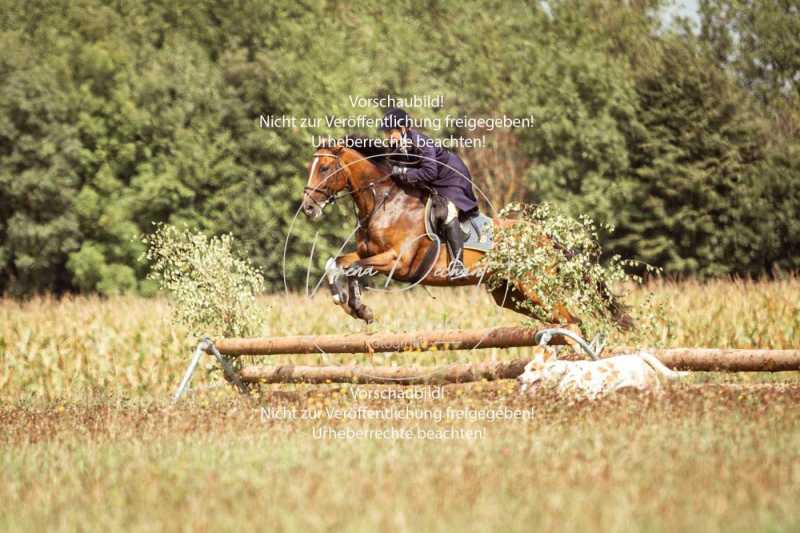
[301,139,628,334]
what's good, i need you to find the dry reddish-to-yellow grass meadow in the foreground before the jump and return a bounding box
[0,383,800,533]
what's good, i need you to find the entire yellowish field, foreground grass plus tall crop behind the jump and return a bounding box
[0,277,800,531]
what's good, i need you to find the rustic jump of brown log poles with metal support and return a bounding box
[175,327,800,394]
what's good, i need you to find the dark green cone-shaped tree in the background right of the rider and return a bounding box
[612,37,768,275]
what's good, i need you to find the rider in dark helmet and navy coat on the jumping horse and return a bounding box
[380,108,478,279]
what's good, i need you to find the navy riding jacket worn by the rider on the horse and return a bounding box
[401,128,478,212]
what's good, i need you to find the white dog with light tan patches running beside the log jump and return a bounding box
[517,348,688,400]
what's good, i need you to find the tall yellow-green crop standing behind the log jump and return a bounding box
[0,277,800,400]
